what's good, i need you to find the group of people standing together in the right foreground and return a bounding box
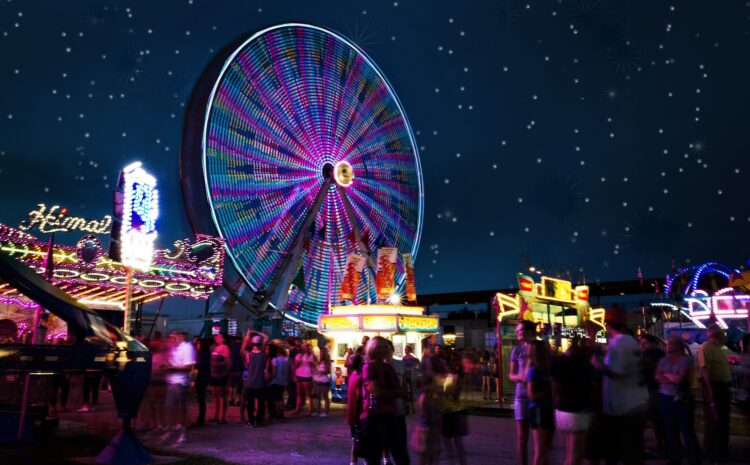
[509,306,750,465]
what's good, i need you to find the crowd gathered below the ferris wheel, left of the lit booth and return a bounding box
[139,330,344,444]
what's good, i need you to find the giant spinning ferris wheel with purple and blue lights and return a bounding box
[181,23,424,326]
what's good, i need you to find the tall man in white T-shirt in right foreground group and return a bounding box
[594,306,648,465]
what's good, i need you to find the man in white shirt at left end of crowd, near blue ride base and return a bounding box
[164,331,195,444]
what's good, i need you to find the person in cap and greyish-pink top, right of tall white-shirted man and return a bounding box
[654,336,701,465]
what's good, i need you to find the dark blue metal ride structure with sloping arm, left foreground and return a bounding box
[0,254,153,464]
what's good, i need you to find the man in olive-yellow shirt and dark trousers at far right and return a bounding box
[698,323,732,462]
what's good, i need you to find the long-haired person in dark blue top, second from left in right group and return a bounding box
[526,341,555,465]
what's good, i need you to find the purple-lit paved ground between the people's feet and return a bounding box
[8,384,750,465]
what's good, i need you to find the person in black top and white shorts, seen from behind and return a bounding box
[551,337,594,465]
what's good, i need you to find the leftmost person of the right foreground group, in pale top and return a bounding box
[508,320,536,465]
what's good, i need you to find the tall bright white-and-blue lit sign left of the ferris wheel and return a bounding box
[113,162,159,271]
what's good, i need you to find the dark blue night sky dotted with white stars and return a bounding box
[0,0,750,293]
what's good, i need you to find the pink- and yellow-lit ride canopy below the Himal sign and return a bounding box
[0,224,224,324]
